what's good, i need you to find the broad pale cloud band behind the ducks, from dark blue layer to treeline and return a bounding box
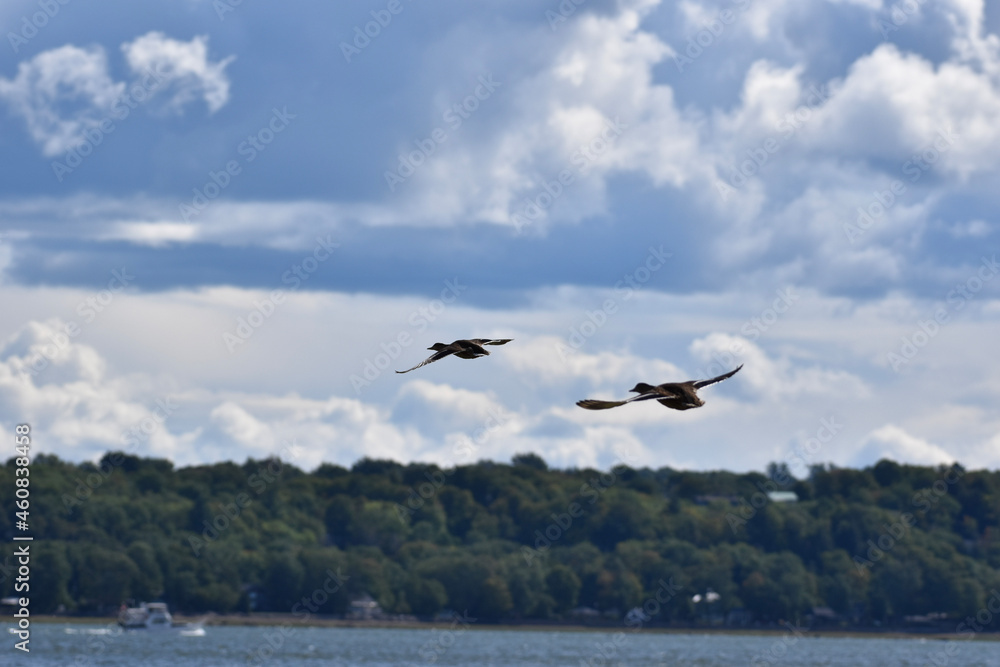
[0,288,1000,470]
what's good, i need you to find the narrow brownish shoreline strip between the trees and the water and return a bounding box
[17,612,1000,641]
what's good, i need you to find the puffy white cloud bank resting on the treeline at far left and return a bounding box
[0,319,412,467]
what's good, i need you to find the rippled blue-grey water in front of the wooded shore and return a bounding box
[7,623,1000,667]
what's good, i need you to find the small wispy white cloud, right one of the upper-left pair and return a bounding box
[122,32,236,113]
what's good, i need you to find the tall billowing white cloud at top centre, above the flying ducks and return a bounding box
[376,2,708,231]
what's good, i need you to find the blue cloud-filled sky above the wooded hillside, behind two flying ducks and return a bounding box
[0,0,1000,477]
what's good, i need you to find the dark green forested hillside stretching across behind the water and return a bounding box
[0,453,1000,627]
